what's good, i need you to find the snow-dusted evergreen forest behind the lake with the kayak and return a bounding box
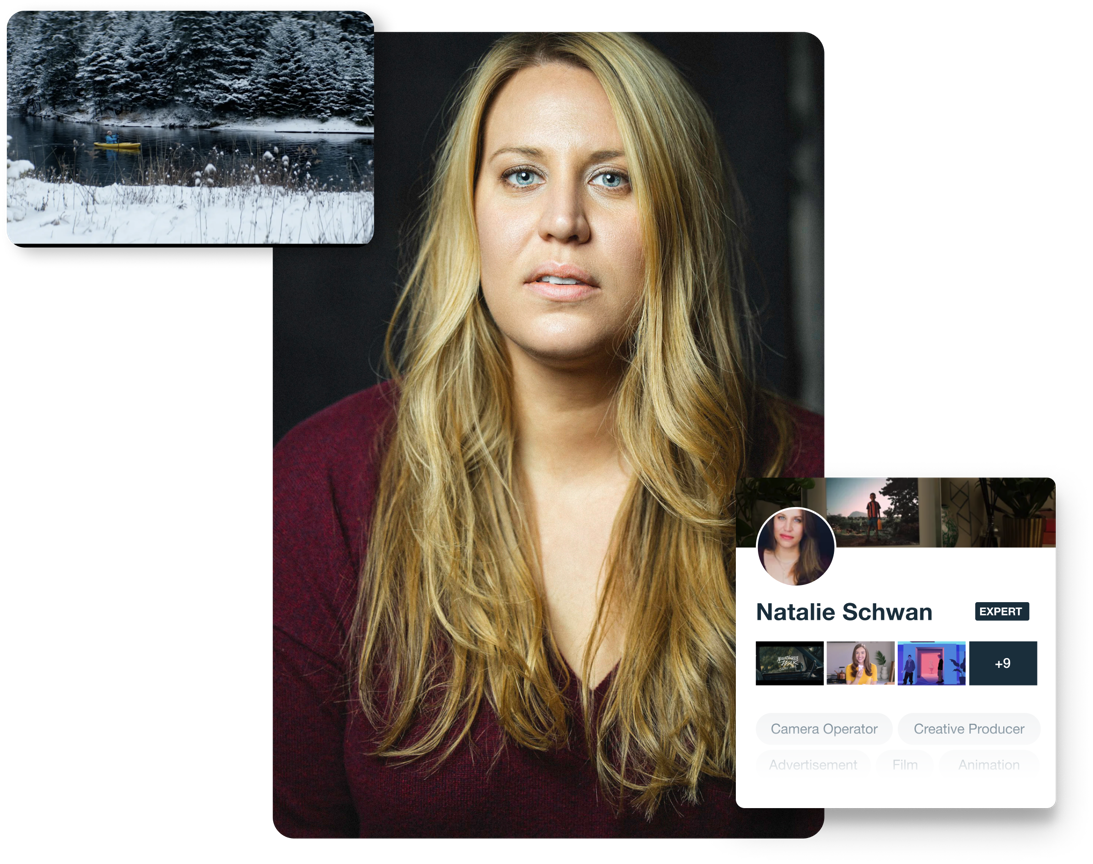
[4,9,374,125]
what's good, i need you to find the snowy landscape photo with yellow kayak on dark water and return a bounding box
[4,9,375,245]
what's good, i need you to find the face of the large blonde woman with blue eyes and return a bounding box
[474,62,645,369]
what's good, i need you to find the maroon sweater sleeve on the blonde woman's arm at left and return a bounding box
[271,384,396,837]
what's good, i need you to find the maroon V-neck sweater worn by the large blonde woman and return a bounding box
[273,385,823,840]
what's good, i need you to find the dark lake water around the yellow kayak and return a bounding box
[7,116,374,189]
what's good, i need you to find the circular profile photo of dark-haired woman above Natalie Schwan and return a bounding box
[756,507,835,585]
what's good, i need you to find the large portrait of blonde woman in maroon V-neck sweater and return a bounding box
[273,33,822,838]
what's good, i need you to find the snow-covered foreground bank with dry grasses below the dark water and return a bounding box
[5,170,374,244]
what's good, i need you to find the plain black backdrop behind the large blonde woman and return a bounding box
[272,31,823,443]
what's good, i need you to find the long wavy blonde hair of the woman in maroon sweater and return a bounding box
[352,33,789,818]
